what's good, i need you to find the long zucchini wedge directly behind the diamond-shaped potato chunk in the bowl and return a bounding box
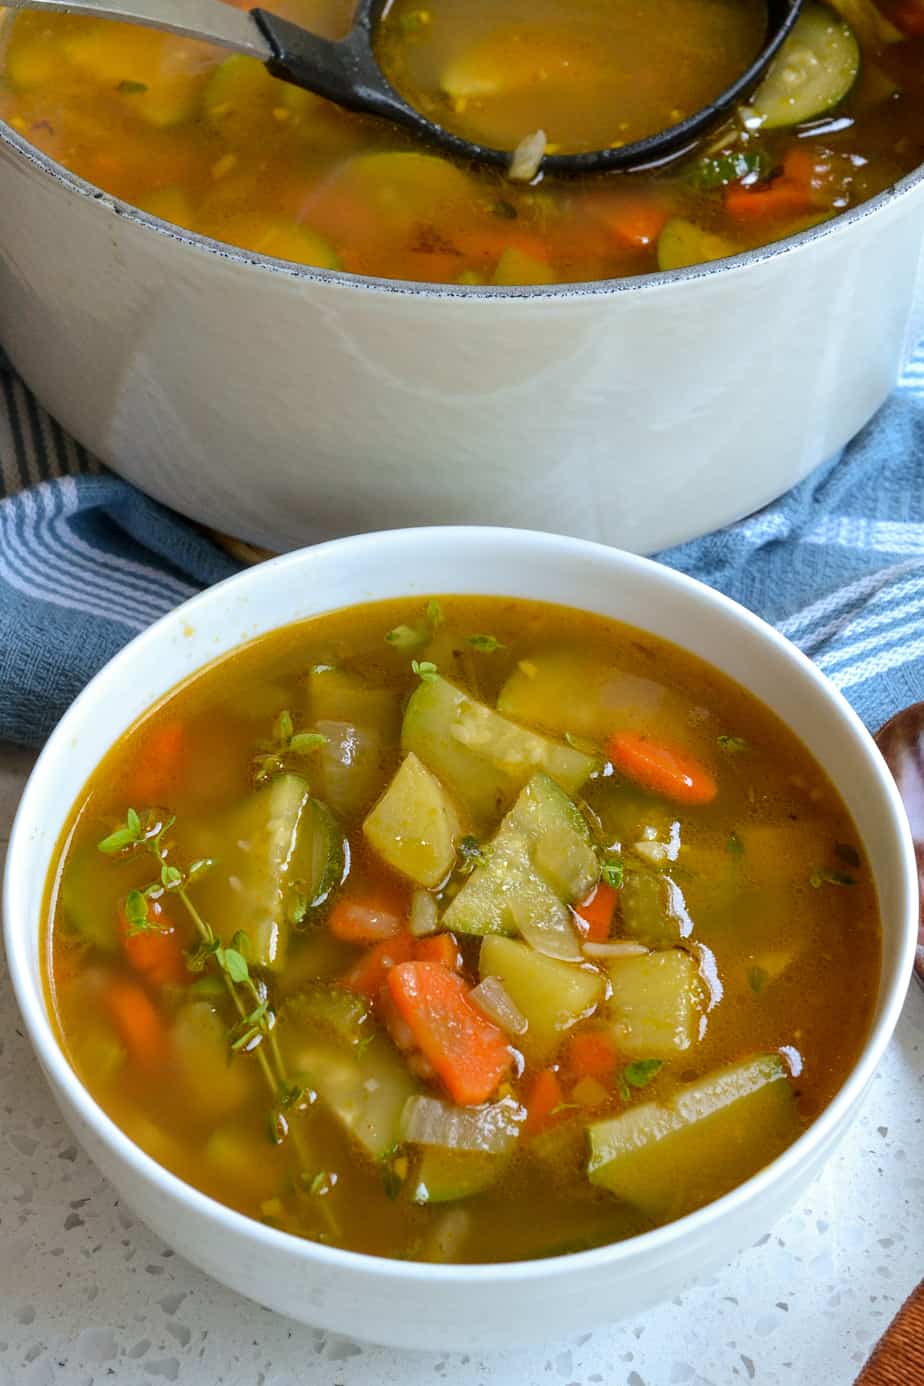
[402,676,593,830]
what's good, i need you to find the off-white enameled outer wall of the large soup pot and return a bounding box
[0,126,924,552]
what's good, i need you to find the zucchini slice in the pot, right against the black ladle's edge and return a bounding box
[748,4,860,130]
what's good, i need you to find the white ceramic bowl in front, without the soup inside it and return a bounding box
[3,527,917,1351]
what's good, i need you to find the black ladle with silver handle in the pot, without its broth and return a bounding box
[3,0,802,173]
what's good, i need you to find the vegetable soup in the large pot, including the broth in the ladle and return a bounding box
[0,0,924,286]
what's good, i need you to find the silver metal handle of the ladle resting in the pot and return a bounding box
[3,0,273,62]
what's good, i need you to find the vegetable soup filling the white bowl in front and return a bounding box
[46,596,880,1263]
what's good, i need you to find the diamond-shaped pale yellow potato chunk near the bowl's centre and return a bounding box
[363,751,463,890]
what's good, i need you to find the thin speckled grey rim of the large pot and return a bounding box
[0,102,924,302]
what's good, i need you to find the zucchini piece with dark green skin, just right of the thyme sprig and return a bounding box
[195,775,344,970]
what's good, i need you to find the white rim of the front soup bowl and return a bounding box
[3,525,918,1286]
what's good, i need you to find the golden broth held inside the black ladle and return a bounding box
[380,0,766,154]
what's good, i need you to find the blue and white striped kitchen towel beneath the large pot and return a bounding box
[0,342,924,746]
